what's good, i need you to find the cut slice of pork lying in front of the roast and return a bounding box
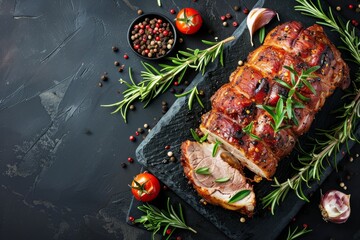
[181,141,256,216]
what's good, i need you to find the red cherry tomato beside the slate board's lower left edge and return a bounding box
[131,172,161,202]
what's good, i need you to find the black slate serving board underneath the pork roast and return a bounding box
[136,0,359,239]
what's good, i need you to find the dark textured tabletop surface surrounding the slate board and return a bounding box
[0,0,360,240]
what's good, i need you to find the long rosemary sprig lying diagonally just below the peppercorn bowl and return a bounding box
[102,36,235,122]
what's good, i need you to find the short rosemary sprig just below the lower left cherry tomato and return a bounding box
[135,198,196,239]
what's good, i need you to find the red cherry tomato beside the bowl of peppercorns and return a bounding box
[175,8,202,34]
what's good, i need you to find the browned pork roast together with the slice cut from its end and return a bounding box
[181,21,350,216]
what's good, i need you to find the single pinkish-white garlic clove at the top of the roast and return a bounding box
[246,8,280,46]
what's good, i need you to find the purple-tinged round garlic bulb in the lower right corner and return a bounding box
[319,190,350,223]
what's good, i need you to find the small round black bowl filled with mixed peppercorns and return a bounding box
[127,13,177,60]
